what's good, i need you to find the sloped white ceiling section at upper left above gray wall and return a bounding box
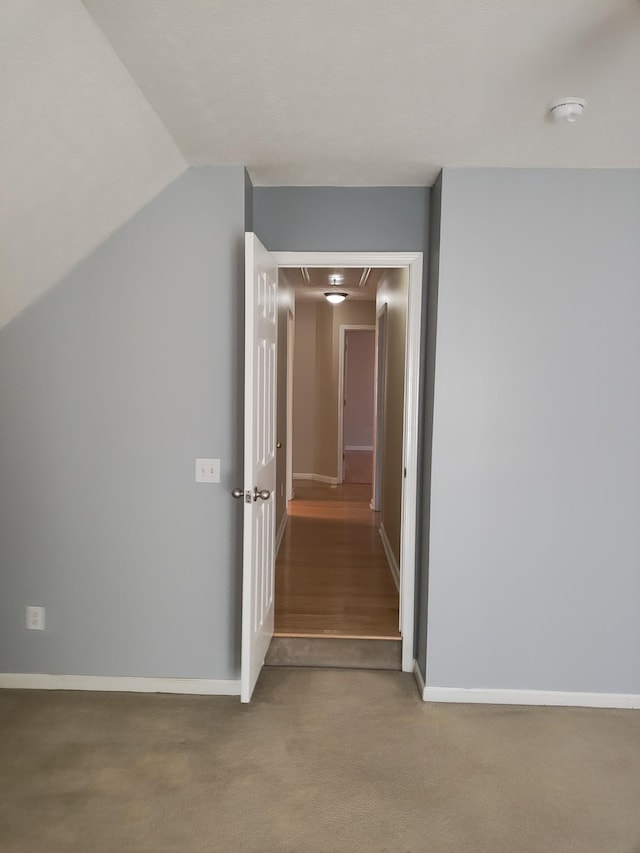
[0,0,186,326]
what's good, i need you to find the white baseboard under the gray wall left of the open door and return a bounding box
[0,672,240,696]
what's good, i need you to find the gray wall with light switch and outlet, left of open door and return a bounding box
[0,167,245,679]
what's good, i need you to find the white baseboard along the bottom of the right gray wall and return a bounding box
[422,687,640,708]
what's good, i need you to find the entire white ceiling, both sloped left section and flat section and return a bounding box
[0,0,640,326]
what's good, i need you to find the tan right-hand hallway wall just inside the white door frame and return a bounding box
[376,269,409,565]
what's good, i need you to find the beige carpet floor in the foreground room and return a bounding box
[0,668,640,853]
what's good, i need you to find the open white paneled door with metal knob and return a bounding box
[240,234,278,702]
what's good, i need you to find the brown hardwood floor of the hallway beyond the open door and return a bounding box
[275,480,400,639]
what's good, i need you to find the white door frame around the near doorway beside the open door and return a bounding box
[271,252,422,672]
